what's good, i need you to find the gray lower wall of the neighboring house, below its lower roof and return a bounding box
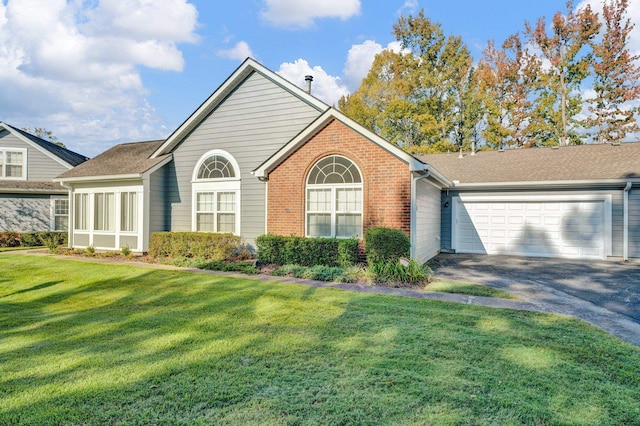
[0,194,51,232]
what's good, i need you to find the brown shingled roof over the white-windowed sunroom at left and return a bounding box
[54,140,171,182]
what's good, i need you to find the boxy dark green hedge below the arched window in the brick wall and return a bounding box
[256,234,358,267]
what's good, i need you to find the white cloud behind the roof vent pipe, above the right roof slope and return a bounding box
[278,59,349,105]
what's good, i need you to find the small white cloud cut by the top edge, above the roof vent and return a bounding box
[262,0,360,29]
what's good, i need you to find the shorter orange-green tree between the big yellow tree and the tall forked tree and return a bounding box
[478,33,540,148]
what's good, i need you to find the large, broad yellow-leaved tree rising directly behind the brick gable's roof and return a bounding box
[338,11,470,149]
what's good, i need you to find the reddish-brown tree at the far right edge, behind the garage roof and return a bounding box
[586,0,640,143]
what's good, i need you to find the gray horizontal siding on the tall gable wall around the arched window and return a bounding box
[166,73,321,243]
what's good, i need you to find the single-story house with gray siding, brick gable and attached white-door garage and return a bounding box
[55,59,640,260]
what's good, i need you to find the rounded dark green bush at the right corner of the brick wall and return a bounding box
[364,228,411,265]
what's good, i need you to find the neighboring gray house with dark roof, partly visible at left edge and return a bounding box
[0,122,87,232]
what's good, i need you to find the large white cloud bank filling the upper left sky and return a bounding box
[0,0,198,155]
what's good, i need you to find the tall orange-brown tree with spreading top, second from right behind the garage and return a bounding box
[525,1,600,145]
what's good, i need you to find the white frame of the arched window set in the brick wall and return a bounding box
[304,155,364,239]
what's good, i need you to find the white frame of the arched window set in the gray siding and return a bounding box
[191,149,241,235]
